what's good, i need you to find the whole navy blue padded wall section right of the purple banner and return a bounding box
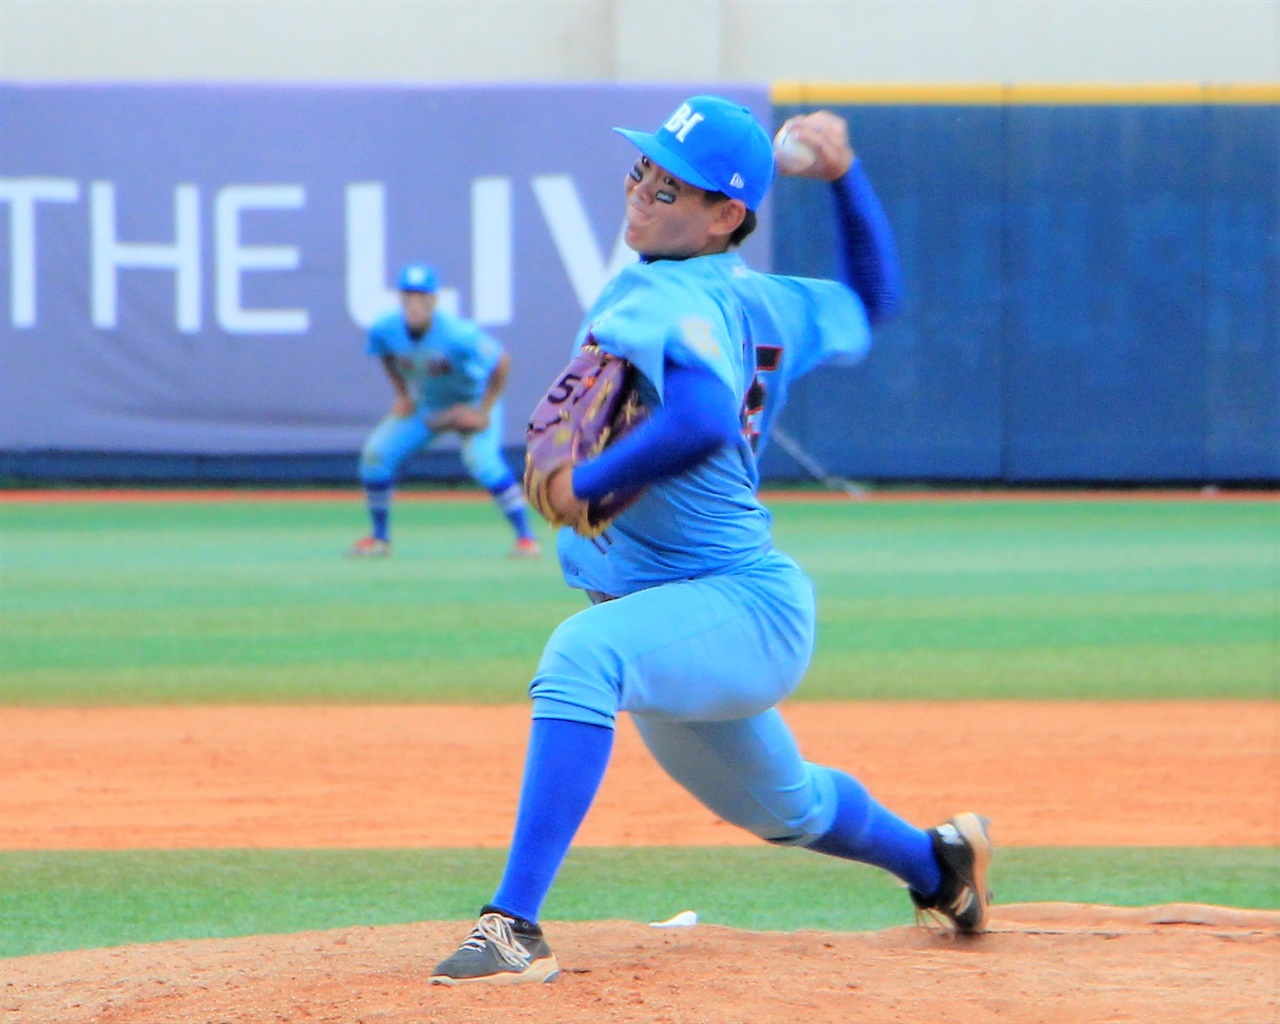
[763,97,1280,483]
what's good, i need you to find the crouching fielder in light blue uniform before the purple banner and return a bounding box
[348,264,541,558]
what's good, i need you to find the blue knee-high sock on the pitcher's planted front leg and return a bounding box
[492,718,613,922]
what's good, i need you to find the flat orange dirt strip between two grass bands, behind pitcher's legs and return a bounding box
[0,701,1280,850]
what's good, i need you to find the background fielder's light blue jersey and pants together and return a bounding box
[360,308,511,492]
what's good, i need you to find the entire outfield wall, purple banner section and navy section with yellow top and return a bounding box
[0,83,1280,484]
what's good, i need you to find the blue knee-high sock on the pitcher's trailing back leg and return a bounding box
[809,768,942,896]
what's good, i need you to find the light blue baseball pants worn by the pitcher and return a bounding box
[530,552,837,845]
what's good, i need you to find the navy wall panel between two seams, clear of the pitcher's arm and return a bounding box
[1004,106,1206,480]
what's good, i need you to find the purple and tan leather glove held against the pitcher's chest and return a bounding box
[525,342,649,536]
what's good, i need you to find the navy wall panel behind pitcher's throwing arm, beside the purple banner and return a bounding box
[762,106,1002,479]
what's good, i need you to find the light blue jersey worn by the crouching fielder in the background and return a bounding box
[366,308,503,412]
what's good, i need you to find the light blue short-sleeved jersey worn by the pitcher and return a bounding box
[558,252,869,596]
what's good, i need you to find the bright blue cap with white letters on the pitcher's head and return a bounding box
[613,96,773,210]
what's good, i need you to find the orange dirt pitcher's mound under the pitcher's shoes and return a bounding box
[0,904,1280,1024]
